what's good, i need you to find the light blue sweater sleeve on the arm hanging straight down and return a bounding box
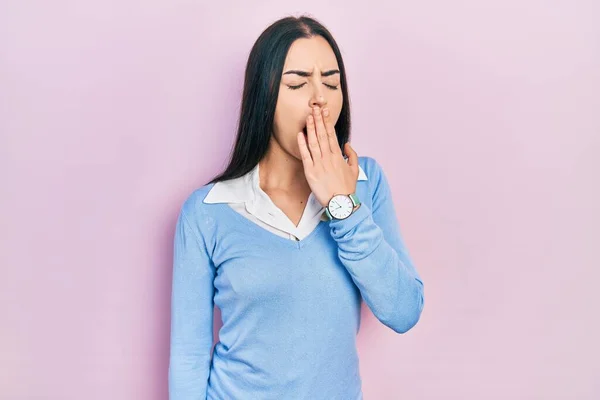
[168,203,215,400]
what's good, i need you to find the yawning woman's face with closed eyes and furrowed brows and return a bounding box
[273,36,343,160]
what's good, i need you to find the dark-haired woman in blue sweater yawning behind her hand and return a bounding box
[169,17,423,400]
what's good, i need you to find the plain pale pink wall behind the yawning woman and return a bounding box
[0,0,600,400]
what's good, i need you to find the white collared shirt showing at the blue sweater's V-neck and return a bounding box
[204,164,367,240]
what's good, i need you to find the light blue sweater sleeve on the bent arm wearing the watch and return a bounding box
[329,157,424,333]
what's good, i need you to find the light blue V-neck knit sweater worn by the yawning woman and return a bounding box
[169,156,424,400]
